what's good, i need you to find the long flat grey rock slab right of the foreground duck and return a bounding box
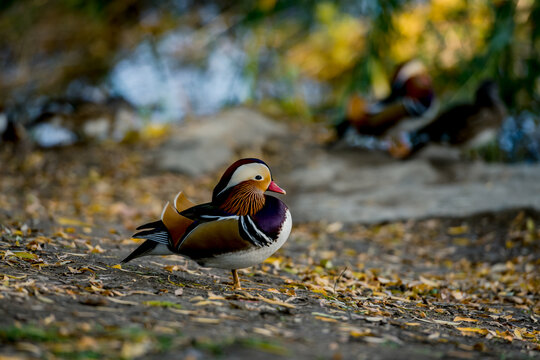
[279,146,540,224]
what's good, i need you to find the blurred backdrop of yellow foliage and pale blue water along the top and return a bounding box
[0,0,540,161]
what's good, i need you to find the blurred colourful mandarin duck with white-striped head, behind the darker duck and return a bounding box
[336,60,434,138]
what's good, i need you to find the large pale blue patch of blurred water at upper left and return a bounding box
[109,29,250,121]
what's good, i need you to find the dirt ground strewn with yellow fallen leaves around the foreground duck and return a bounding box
[0,139,540,360]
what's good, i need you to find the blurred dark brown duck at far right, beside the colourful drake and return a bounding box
[389,80,506,159]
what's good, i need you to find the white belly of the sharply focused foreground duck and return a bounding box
[197,210,292,269]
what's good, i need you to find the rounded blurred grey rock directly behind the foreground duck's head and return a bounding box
[156,108,287,176]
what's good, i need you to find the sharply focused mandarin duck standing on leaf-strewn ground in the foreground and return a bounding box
[122,158,292,289]
